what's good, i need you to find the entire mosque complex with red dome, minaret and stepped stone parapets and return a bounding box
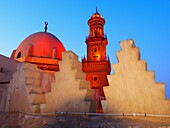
[0,9,170,114]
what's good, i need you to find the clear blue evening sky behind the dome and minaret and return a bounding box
[0,0,170,99]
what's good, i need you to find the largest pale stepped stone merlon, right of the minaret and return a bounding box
[103,40,170,114]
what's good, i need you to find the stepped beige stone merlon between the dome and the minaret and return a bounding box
[42,51,95,112]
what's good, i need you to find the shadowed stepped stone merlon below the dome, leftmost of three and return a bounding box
[8,63,45,113]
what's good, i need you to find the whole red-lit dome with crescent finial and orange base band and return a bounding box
[11,22,66,71]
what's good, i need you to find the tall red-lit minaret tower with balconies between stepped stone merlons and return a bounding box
[82,8,111,112]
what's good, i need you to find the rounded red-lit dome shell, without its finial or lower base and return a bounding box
[14,32,66,60]
